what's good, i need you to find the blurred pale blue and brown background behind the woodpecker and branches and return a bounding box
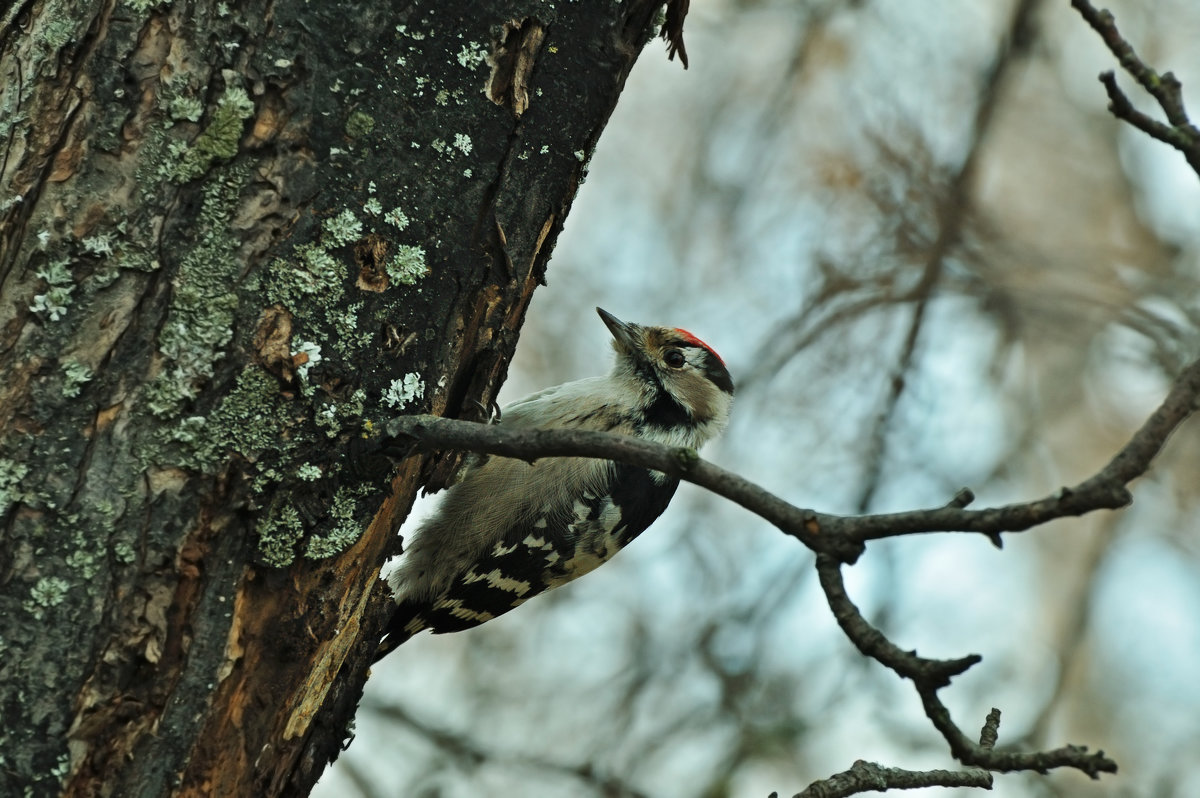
[316,0,1200,797]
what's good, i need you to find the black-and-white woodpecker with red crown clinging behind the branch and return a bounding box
[376,307,733,660]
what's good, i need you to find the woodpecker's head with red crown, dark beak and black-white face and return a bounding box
[596,307,733,443]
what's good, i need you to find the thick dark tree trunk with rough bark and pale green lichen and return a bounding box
[0,0,682,796]
